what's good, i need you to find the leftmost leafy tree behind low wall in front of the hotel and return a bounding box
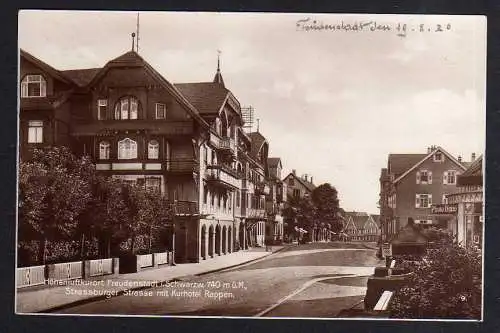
[19,147,94,262]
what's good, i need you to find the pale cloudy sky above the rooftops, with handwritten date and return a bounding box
[19,11,486,213]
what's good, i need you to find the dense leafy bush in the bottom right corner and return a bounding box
[390,241,482,319]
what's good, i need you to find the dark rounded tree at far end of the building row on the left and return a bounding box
[311,183,342,233]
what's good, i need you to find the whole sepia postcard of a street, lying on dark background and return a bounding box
[15,10,486,321]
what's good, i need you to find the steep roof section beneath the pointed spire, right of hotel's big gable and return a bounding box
[174,82,229,115]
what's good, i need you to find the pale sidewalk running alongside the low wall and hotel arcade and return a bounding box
[16,246,285,314]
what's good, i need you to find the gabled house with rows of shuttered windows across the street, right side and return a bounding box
[380,146,472,240]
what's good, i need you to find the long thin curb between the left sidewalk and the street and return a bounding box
[37,246,288,314]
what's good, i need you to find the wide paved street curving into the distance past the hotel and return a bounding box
[59,243,380,317]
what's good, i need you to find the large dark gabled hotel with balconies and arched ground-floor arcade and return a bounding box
[19,44,282,262]
